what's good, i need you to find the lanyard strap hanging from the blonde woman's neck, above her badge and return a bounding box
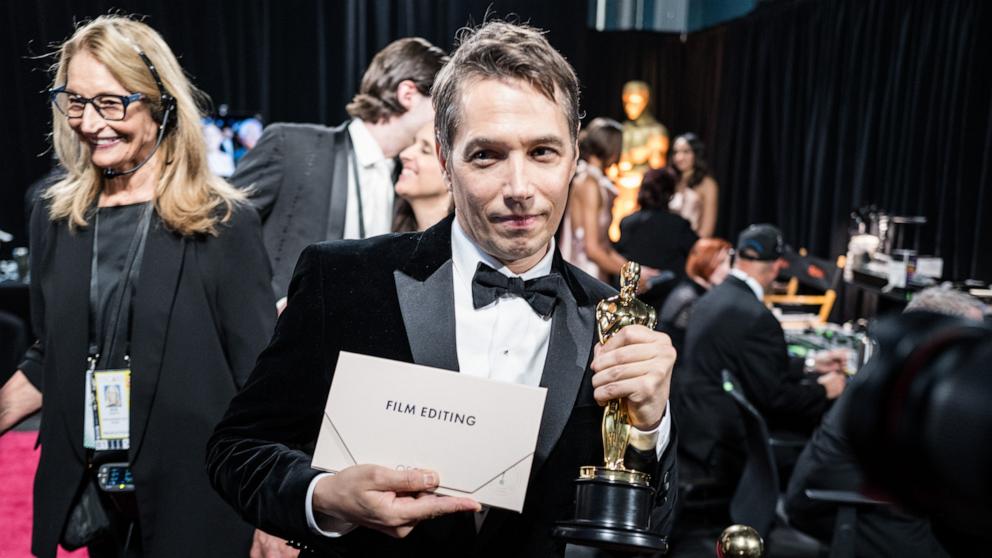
[89,202,153,365]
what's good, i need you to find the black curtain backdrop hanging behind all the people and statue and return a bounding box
[0,0,992,280]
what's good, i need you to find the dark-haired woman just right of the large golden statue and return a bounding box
[669,132,720,238]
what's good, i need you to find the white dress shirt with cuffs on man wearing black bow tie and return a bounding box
[306,219,672,537]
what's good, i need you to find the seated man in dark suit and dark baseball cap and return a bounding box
[674,224,845,489]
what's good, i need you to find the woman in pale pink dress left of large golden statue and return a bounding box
[560,118,657,287]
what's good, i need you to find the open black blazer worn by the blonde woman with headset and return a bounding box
[20,203,275,558]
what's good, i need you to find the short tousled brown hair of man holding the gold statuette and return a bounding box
[431,21,580,158]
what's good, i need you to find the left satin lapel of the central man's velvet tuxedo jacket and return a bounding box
[393,217,458,371]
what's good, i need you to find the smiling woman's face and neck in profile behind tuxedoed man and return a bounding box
[393,122,455,232]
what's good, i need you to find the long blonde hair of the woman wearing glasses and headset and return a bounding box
[45,15,246,235]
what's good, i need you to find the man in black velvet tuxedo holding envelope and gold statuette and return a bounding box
[208,22,675,557]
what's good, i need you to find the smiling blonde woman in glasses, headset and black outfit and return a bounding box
[0,16,275,558]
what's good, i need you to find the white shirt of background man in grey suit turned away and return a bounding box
[344,118,395,238]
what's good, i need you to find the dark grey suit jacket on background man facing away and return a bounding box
[231,120,388,298]
